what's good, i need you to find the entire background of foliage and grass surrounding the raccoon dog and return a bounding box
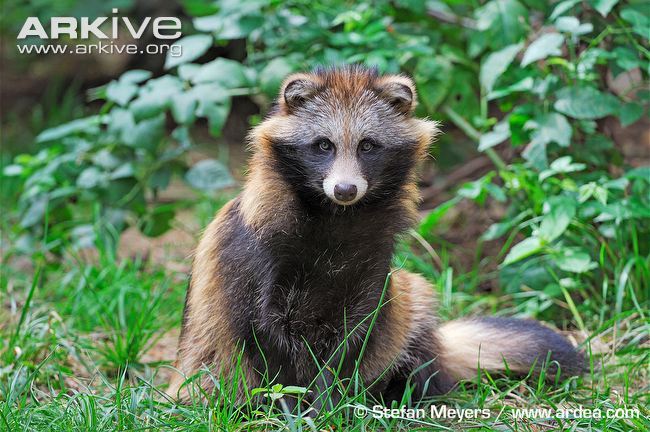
[0,0,650,429]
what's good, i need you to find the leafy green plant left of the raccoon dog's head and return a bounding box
[4,67,238,253]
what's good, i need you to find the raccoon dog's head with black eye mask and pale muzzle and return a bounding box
[254,66,437,207]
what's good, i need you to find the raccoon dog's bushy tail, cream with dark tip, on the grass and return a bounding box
[440,318,585,380]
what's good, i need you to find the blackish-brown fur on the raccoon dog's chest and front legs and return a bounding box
[220,198,405,381]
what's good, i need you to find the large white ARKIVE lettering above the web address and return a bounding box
[17,9,181,39]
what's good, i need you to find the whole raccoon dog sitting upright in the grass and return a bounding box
[169,66,583,408]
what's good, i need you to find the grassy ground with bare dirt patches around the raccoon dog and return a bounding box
[0,175,650,431]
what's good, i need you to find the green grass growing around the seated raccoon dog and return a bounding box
[0,204,650,431]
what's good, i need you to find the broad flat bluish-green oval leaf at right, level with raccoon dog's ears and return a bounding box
[553,86,620,120]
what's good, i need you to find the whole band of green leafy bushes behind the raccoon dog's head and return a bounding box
[4,0,650,317]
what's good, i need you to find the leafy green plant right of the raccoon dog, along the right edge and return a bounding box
[416,1,650,320]
